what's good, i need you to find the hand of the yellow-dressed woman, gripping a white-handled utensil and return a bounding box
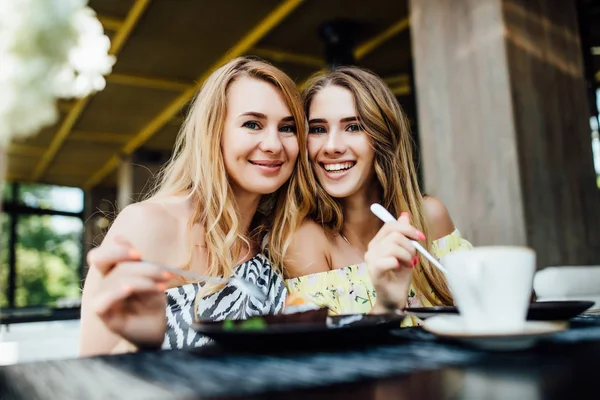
[365,213,425,314]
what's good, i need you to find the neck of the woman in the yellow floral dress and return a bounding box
[341,183,383,253]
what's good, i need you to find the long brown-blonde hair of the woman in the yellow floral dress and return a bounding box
[302,67,453,304]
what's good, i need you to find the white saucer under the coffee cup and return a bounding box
[423,315,568,351]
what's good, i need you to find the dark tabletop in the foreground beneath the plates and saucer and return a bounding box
[0,315,600,400]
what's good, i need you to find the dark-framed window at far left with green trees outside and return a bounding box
[0,183,84,316]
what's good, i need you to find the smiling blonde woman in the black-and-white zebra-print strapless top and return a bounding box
[80,58,313,355]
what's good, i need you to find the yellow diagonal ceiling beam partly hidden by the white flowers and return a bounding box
[32,0,150,181]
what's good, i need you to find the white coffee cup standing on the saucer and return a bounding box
[442,246,536,333]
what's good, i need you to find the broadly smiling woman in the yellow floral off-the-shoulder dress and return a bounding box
[285,67,470,320]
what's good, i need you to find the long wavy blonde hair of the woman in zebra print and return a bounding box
[150,57,315,276]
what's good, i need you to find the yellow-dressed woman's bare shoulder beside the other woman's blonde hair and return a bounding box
[284,219,330,278]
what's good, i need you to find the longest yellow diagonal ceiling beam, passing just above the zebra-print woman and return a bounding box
[83,0,303,190]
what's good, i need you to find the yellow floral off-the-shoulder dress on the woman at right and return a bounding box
[285,229,472,326]
